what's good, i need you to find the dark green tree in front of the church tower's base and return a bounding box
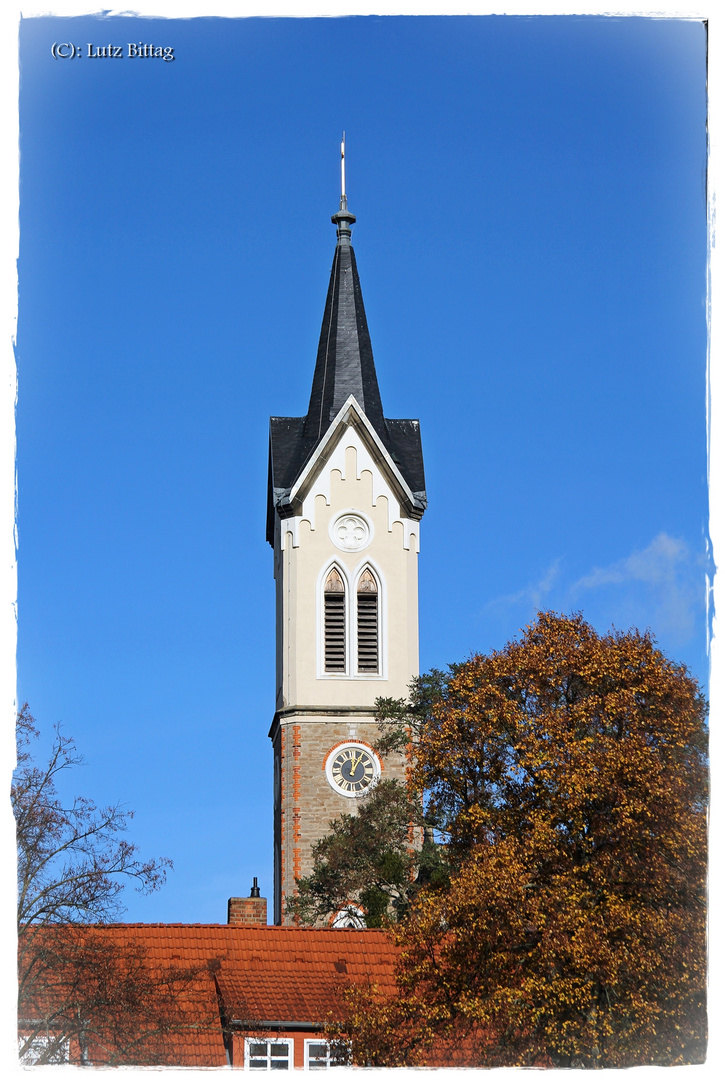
[287,780,447,927]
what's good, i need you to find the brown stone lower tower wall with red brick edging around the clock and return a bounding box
[277,716,405,926]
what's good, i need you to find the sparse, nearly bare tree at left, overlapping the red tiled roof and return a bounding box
[12,705,218,1065]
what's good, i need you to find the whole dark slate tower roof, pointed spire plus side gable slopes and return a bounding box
[267,194,426,545]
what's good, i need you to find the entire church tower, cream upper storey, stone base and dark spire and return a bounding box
[267,144,426,924]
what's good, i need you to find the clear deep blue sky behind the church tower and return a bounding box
[17,16,709,921]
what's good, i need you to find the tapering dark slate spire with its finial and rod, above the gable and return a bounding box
[305,135,385,440]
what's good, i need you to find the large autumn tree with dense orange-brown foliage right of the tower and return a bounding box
[348,612,708,1068]
